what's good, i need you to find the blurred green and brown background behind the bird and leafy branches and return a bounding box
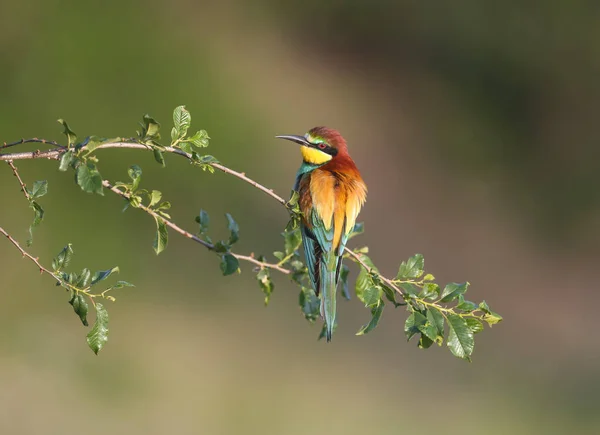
[0,0,600,434]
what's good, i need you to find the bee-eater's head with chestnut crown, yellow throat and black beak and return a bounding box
[276,127,347,165]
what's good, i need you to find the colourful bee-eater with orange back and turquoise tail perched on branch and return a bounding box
[277,127,367,341]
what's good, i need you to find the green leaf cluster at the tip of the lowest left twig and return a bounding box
[52,243,133,354]
